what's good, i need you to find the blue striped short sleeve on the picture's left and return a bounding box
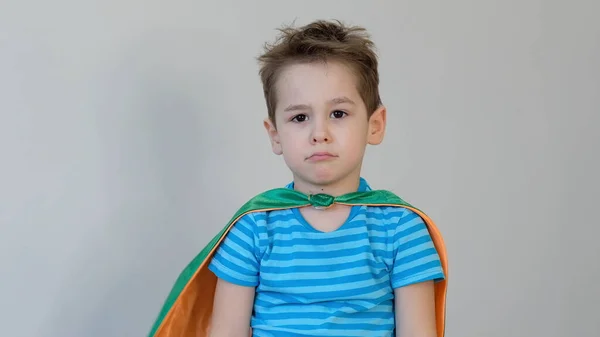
[208,214,259,287]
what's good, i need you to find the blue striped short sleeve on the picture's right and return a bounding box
[392,209,444,289]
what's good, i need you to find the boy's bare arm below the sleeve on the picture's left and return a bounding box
[210,279,255,337]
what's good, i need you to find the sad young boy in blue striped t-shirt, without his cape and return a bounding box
[209,21,444,337]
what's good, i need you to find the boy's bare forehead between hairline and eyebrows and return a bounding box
[276,62,360,108]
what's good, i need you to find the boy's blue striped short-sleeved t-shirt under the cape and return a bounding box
[209,179,444,337]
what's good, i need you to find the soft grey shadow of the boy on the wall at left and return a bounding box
[44,32,222,337]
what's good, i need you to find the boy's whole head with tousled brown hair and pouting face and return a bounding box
[259,21,385,187]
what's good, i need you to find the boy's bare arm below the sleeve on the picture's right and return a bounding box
[394,281,436,337]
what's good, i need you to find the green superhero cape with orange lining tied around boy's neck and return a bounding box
[148,188,448,337]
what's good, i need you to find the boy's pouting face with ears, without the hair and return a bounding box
[265,62,385,187]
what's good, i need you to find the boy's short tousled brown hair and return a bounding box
[258,20,381,123]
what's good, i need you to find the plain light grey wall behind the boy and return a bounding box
[0,0,600,337]
